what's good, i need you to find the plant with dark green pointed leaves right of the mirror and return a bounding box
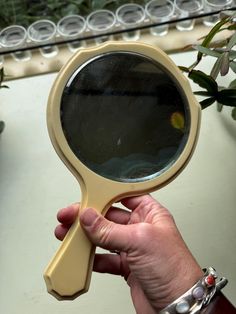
[180,11,236,120]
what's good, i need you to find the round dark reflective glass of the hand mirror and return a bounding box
[61,52,190,182]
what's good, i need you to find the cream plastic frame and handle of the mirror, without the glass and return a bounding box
[44,42,201,300]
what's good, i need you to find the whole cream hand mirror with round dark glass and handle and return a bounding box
[44,42,201,299]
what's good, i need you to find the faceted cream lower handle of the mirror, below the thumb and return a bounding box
[44,219,95,300]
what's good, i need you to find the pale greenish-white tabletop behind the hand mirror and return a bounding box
[0,52,236,314]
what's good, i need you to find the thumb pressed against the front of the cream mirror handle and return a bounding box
[80,208,133,252]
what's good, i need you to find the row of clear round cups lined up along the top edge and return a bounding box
[0,0,235,61]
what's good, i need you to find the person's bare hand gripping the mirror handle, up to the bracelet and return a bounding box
[55,195,202,314]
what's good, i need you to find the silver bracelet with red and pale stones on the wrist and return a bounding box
[159,267,228,314]
